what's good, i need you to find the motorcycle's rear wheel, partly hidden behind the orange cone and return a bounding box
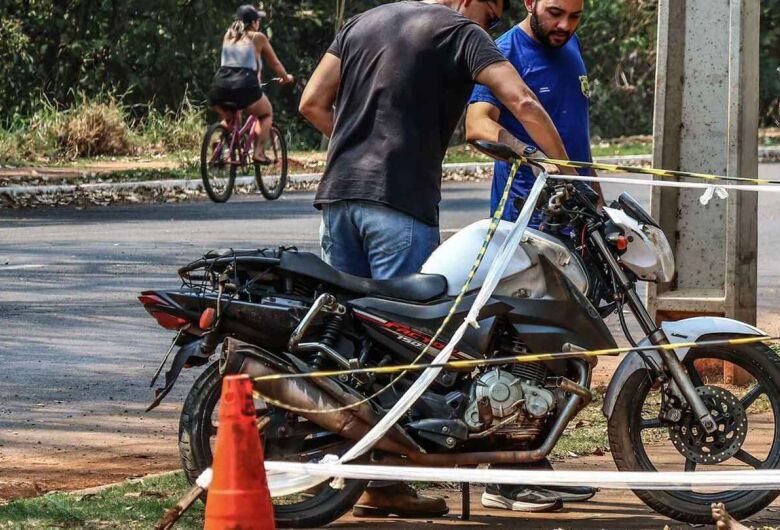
[179,363,367,528]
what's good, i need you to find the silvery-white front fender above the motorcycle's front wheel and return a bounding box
[602,317,766,419]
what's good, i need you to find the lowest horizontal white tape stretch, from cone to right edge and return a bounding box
[265,462,780,493]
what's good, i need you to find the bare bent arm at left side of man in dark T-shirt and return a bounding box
[298,53,341,138]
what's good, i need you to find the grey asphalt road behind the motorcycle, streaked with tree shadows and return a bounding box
[0,165,780,524]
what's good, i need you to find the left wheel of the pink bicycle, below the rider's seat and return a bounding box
[200,123,236,202]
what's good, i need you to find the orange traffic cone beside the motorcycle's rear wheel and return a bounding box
[204,375,275,530]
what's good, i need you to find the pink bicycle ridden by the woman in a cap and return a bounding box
[200,80,288,202]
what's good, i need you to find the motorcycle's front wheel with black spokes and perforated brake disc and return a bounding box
[608,337,780,524]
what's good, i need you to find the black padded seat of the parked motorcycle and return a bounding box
[278,252,447,302]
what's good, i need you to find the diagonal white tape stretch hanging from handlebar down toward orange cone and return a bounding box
[268,173,547,497]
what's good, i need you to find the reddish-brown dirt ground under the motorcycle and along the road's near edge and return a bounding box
[6,358,780,530]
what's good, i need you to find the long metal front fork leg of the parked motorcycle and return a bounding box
[590,230,718,433]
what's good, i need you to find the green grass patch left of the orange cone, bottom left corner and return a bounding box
[0,473,203,530]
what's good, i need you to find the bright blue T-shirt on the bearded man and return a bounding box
[469,26,592,227]
